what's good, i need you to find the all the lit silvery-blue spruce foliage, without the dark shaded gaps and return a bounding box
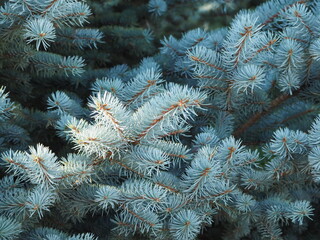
[0,0,320,240]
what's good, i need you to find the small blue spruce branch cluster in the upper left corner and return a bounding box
[0,0,102,84]
